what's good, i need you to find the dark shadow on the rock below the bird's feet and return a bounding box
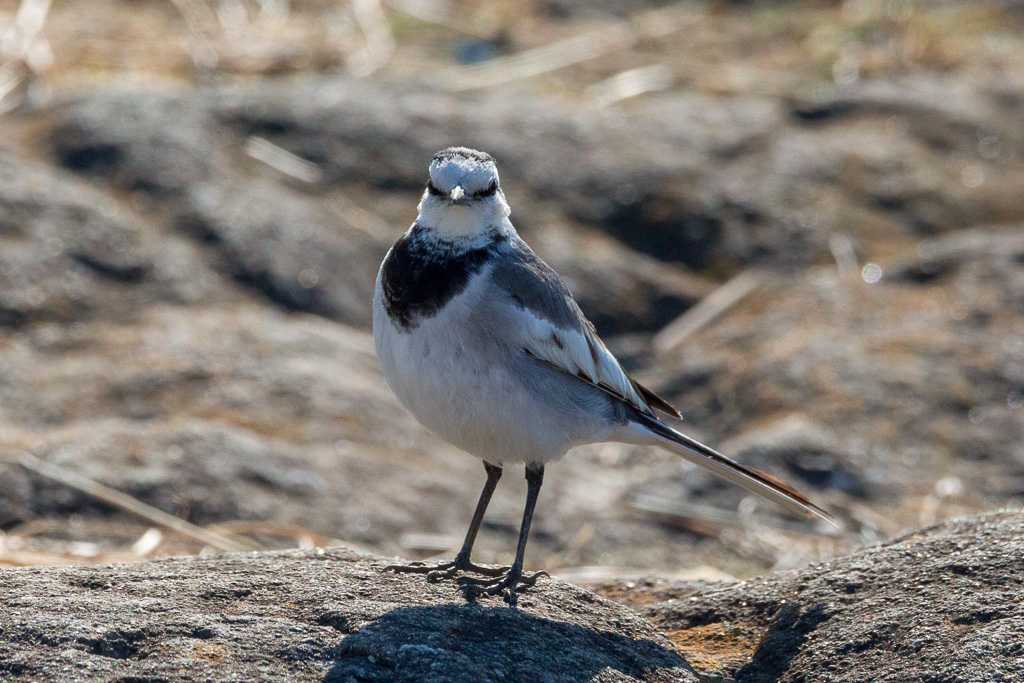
[324,604,692,683]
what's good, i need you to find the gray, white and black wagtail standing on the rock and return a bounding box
[373,146,833,607]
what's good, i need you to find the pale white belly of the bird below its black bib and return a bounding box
[374,270,572,464]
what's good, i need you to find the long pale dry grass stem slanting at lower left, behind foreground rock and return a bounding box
[14,453,260,552]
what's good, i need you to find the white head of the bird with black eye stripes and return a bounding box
[417,147,509,238]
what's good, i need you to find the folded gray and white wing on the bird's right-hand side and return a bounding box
[490,237,681,417]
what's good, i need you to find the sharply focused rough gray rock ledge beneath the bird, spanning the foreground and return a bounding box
[0,512,1024,683]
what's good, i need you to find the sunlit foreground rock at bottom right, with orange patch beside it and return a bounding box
[606,512,1024,683]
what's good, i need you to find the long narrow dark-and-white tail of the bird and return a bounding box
[634,414,839,527]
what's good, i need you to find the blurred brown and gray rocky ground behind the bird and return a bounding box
[0,0,1024,582]
